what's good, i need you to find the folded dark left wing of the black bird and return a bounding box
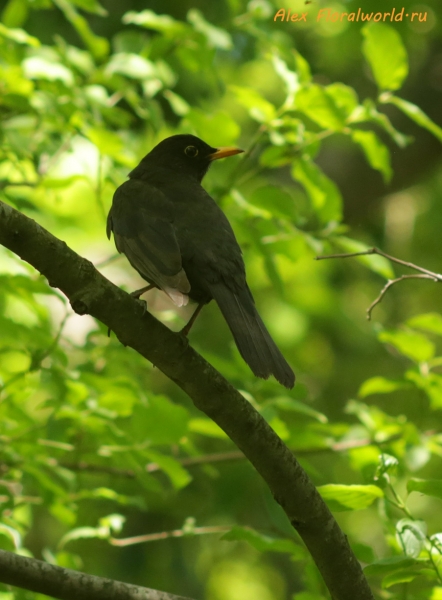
[107,179,190,306]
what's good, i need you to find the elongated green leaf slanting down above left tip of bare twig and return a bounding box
[292,155,342,224]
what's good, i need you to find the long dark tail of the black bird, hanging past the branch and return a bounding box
[210,283,295,388]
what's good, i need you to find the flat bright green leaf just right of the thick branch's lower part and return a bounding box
[318,484,384,511]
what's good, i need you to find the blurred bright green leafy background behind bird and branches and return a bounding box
[0,0,442,600]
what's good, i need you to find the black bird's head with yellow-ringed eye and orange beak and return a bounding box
[130,134,244,181]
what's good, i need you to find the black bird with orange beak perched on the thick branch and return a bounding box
[107,135,295,388]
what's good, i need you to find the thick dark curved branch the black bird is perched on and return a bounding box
[0,202,373,600]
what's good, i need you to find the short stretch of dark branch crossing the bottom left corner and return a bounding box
[0,550,193,600]
